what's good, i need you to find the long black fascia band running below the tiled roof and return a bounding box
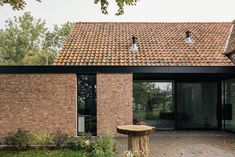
[0,66,235,74]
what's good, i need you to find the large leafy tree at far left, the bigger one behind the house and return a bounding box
[0,13,46,65]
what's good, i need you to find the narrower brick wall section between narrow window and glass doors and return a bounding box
[97,74,133,135]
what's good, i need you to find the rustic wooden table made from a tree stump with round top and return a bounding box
[117,125,155,157]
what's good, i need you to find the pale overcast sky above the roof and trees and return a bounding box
[0,0,235,28]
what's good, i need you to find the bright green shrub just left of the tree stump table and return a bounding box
[91,134,115,157]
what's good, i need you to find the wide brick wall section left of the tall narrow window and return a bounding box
[0,74,77,135]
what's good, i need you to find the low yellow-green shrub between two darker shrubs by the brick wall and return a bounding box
[29,133,53,145]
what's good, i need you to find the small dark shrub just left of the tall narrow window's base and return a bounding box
[52,130,68,149]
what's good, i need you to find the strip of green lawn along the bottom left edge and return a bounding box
[0,150,87,157]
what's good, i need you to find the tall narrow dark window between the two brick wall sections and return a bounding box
[78,75,96,134]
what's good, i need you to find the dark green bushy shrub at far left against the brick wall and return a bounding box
[4,129,29,150]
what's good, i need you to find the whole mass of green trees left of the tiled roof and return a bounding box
[0,12,73,65]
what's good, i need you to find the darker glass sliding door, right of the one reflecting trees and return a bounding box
[177,82,218,129]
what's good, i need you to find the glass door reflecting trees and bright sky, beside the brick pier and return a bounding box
[134,80,175,130]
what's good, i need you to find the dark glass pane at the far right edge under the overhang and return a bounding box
[224,79,235,131]
